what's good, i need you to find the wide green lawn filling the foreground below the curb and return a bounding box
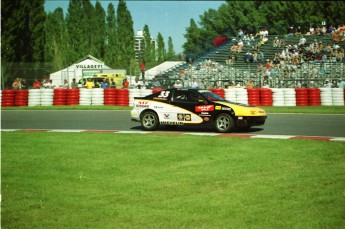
[1,132,345,229]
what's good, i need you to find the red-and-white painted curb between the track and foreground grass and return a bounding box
[1,129,345,142]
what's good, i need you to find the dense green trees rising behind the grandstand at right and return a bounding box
[183,0,345,56]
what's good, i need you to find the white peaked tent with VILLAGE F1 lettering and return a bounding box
[50,55,111,86]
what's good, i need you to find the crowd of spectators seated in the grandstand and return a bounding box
[172,22,345,87]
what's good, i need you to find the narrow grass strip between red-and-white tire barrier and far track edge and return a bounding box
[1,106,345,114]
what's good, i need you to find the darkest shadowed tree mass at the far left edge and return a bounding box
[1,0,45,87]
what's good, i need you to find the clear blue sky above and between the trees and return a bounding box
[45,0,225,53]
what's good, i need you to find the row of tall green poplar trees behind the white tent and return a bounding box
[1,0,175,86]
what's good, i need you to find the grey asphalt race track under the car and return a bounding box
[1,110,345,137]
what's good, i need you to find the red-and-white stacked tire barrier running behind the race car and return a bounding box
[0,88,345,107]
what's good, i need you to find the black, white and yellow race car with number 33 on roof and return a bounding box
[131,88,267,133]
